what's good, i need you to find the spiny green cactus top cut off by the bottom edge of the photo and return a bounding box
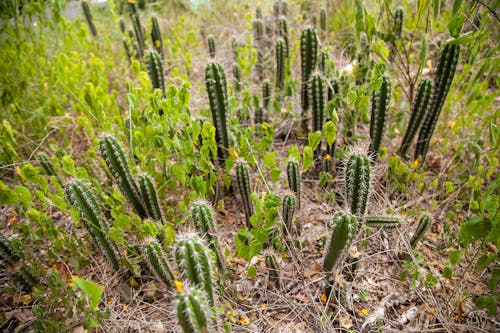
[177,288,215,333]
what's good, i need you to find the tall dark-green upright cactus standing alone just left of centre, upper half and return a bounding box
[205,61,229,167]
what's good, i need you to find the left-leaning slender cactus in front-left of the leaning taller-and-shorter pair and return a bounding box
[65,179,120,270]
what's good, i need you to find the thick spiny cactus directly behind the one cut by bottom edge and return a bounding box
[175,234,214,306]
